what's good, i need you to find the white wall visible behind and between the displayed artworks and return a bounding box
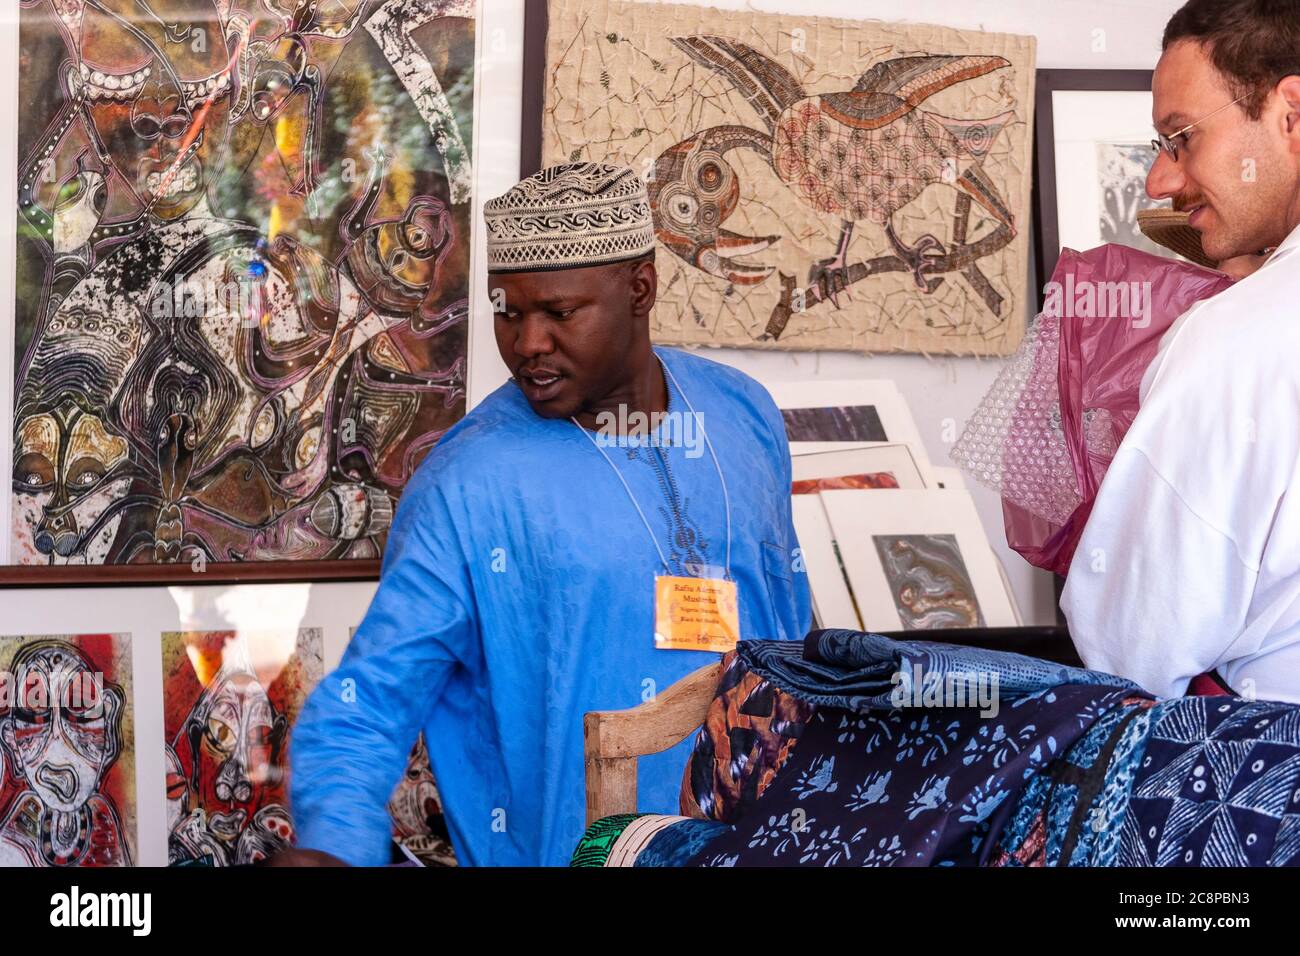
[0,0,1179,865]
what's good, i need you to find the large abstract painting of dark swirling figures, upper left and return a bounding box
[8,0,475,570]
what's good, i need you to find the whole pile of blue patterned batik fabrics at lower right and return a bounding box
[600,631,1300,866]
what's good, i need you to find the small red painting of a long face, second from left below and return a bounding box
[163,628,324,866]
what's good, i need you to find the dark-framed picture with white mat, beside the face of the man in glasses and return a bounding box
[1035,70,1171,290]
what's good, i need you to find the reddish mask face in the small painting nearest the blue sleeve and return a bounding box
[190,670,283,840]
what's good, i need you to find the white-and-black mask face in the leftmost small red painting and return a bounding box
[0,643,118,812]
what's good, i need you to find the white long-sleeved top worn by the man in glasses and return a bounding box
[1061,228,1300,702]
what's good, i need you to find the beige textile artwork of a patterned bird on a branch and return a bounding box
[541,0,1035,355]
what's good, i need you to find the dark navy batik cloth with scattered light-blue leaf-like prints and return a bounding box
[692,631,1136,866]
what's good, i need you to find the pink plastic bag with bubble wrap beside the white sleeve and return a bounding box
[952,245,1232,575]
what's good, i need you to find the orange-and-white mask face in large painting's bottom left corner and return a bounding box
[13,399,127,559]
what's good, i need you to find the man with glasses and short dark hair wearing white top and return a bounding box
[1061,0,1300,702]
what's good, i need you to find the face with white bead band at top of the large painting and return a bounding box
[81,0,235,221]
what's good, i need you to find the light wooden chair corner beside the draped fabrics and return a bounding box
[582,662,723,823]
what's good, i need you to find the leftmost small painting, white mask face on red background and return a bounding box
[0,633,137,866]
